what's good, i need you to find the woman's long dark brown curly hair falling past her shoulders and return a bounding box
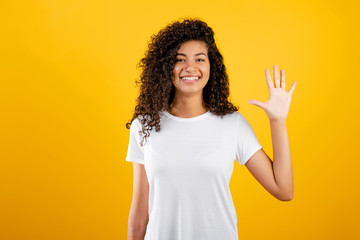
[126,18,239,146]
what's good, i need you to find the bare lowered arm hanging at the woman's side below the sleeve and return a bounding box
[127,163,149,240]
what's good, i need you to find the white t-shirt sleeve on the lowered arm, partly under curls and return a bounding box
[125,118,144,164]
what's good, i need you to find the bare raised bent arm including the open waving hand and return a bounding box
[245,65,296,201]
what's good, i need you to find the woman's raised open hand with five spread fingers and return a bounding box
[248,65,296,121]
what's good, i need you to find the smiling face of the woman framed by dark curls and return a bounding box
[172,40,210,94]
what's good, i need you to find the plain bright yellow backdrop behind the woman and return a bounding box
[0,0,360,240]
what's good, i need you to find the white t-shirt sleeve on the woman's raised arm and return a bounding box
[235,113,262,165]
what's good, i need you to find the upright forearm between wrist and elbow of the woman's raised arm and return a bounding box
[270,120,294,200]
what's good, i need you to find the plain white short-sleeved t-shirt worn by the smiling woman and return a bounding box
[126,111,262,240]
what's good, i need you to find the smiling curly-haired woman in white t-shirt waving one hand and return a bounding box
[126,19,296,240]
